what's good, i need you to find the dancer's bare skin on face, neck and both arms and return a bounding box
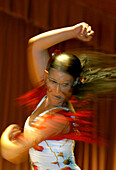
[1,22,94,163]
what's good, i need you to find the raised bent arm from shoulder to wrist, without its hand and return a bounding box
[28,27,74,85]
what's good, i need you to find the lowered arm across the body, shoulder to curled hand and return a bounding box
[1,113,70,164]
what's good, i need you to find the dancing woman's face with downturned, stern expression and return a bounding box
[45,68,74,106]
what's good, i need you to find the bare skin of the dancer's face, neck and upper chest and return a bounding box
[29,68,74,125]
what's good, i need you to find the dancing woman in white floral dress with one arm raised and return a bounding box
[1,23,94,170]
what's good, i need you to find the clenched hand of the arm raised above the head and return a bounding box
[73,22,94,41]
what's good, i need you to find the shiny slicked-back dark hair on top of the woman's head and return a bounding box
[47,52,82,79]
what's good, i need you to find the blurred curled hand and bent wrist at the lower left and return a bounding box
[1,124,28,164]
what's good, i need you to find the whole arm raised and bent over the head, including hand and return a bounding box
[28,22,94,85]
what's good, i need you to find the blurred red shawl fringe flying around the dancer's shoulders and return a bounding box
[18,82,106,144]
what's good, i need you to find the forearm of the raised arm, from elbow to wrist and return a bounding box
[29,26,76,50]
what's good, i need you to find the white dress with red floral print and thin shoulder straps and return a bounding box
[25,96,80,170]
